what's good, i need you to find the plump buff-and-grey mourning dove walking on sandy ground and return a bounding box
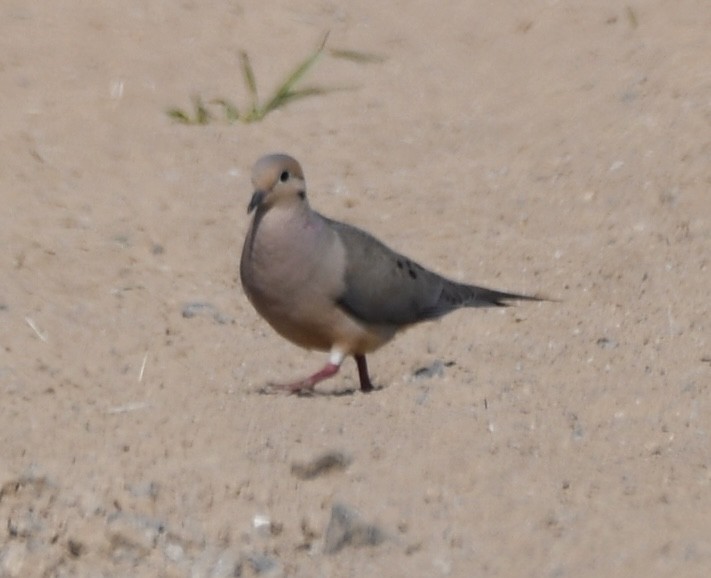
[240,154,540,393]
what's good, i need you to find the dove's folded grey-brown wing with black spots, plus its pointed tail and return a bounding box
[324,217,538,326]
